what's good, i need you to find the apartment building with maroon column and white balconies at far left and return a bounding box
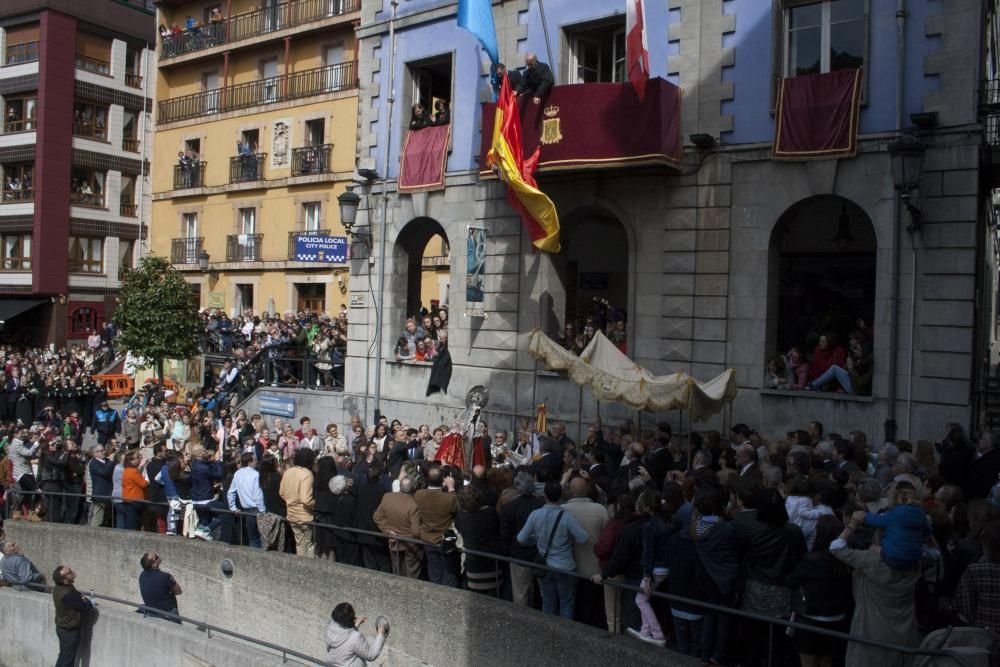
[0,0,156,345]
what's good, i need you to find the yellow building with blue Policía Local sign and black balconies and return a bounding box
[151,0,360,313]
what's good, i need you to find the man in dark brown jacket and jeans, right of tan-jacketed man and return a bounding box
[414,466,458,588]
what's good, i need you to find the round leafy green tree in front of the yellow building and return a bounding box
[113,255,201,380]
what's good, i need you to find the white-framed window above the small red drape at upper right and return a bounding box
[771,0,871,104]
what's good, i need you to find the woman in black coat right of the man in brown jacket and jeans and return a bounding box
[455,484,502,595]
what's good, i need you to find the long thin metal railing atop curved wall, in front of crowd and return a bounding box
[4,490,980,667]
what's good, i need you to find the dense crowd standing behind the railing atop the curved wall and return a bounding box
[3,378,1000,665]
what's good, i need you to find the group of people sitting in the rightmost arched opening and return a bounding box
[765,319,873,396]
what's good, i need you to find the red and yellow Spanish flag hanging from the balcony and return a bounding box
[486,77,559,252]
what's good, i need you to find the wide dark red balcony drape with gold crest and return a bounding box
[479,78,682,176]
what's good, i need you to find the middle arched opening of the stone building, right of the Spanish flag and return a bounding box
[546,208,632,351]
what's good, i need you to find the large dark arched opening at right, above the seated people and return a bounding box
[767,195,878,376]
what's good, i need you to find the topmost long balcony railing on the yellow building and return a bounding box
[160,0,361,60]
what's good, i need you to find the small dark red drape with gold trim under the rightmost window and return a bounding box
[771,69,861,160]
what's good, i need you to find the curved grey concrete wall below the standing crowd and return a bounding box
[0,522,688,667]
